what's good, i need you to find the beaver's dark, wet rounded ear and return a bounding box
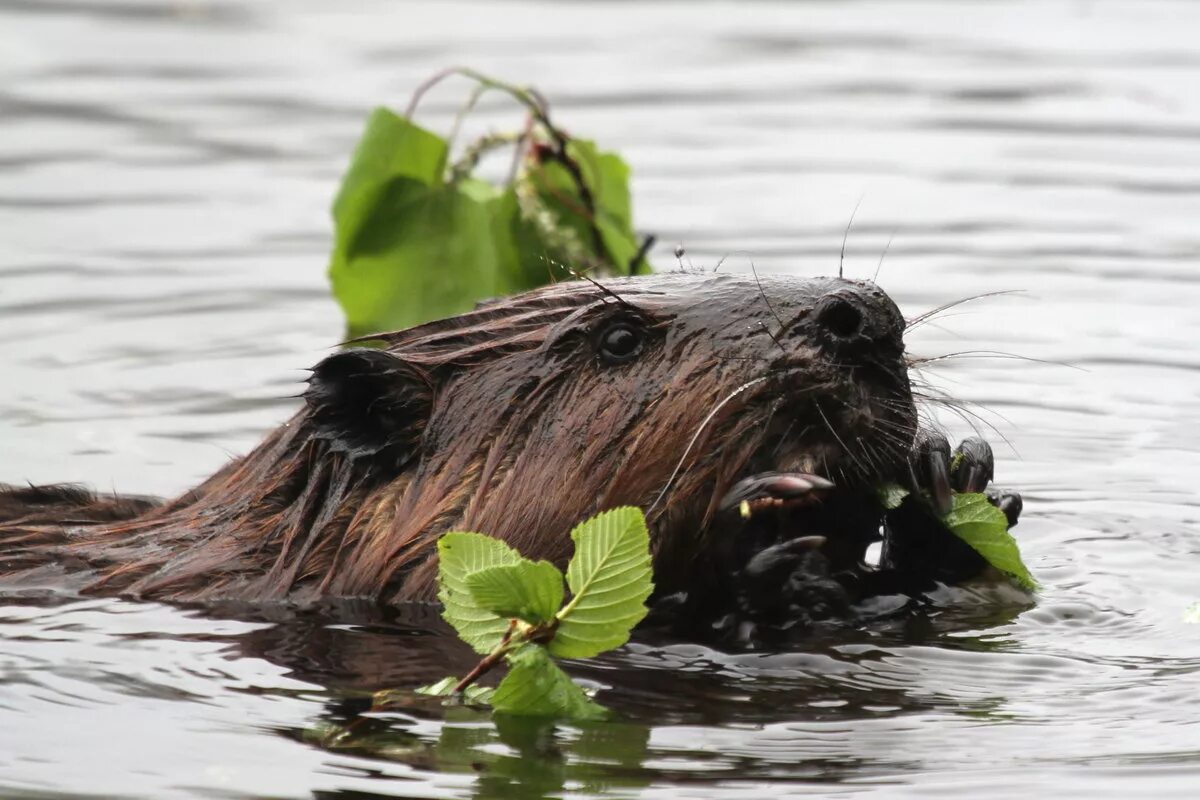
[304,349,433,468]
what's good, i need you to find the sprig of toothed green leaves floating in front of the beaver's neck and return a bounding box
[424,507,654,720]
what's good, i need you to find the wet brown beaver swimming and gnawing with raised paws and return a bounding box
[0,273,1019,642]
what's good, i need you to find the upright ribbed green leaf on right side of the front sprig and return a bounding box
[550,506,654,658]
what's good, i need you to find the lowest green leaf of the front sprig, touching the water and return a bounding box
[492,644,607,720]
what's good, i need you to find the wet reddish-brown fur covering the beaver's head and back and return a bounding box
[0,275,916,600]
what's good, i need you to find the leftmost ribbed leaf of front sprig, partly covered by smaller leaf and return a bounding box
[438,531,524,652]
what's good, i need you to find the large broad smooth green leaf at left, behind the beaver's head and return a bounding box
[329,108,535,336]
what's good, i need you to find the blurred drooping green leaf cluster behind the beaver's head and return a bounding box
[329,73,650,337]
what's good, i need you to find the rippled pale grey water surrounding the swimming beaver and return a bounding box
[0,0,1200,799]
